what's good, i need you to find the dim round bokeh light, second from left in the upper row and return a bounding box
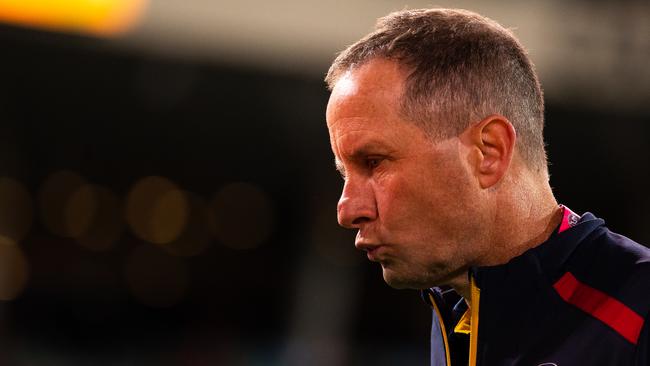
[38,170,88,238]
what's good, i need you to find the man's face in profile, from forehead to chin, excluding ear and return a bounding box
[327,59,481,288]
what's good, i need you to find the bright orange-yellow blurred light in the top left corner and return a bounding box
[0,0,148,37]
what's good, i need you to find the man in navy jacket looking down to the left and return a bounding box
[326,9,650,366]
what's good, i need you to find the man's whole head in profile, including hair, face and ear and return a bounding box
[327,10,546,288]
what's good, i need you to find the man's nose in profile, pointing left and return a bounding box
[337,177,377,229]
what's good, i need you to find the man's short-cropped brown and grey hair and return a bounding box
[325,9,547,173]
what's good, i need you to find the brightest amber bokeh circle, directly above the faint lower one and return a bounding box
[126,176,189,244]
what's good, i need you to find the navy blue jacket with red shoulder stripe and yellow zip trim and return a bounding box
[422,209,650,366]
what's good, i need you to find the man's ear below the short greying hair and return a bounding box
[462,115,517,188]
